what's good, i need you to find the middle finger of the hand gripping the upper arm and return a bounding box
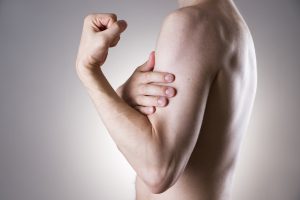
[138,84,176,97]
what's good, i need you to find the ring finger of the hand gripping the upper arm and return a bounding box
[135,95,168,107]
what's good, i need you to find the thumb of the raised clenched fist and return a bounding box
[101,20,127,43]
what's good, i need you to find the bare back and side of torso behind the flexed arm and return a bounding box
[136,2,256,200]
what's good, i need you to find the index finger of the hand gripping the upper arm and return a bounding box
[139,71,175,84]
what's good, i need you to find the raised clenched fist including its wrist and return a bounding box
[76,14,127,87]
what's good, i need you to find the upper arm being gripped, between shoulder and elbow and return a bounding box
[148,12,214,181]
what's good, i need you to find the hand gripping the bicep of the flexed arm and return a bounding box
[116,52,176,115]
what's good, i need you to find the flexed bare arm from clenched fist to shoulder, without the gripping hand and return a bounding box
[76,12,218,193]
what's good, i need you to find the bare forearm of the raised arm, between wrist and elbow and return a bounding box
[87,71,161,183]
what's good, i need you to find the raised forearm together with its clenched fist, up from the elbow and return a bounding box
[76,14,177,189]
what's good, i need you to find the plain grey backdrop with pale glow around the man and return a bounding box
[0,0,300,200]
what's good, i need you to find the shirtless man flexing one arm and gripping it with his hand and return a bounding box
[76,0,256,200]
